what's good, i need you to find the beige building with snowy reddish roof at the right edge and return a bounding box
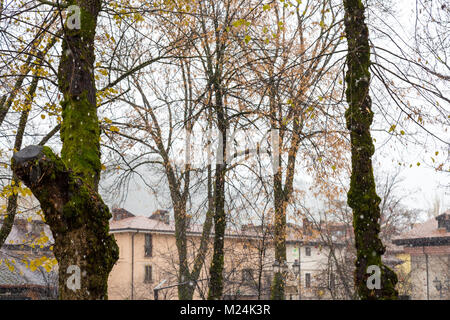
[393,211,450,300]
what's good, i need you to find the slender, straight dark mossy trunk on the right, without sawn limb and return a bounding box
[343,0,397,299]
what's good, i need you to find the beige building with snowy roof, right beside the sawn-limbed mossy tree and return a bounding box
[108,209,273,300]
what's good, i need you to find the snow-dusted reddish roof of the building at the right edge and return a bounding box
[393,213,450,246]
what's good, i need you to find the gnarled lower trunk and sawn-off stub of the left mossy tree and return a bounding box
[12,146,118,300]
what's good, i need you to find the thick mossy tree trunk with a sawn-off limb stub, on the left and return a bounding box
[12,0,118,299]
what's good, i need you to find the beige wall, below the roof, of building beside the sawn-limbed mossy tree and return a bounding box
[108,232,270,300]
